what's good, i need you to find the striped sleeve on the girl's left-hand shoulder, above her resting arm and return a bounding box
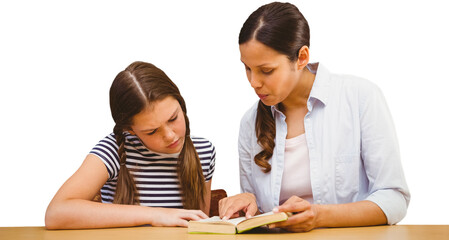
[89,134,120,180]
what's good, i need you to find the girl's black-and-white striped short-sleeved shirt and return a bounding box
[90,133,215,208]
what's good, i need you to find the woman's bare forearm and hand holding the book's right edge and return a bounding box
[270,196,387,232]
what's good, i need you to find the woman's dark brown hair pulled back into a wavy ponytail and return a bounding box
[239,2,310,173]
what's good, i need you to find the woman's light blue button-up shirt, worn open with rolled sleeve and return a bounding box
[239,63,410,224]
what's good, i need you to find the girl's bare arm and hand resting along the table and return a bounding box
[45,154,207,229]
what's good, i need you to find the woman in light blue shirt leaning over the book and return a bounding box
[220,2,410,232]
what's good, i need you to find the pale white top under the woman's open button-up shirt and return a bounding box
[279,134,313,205]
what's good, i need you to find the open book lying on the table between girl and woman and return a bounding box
[188,212,289,234]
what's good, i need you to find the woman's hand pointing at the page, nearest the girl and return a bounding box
[218,193,257,219]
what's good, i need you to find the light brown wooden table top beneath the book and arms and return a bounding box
[0,225,449,240]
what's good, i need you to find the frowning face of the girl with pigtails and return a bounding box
[129,97,186,153]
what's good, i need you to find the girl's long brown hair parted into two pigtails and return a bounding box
[109,62,206,209]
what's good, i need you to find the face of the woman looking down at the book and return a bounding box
[240,39,301,106]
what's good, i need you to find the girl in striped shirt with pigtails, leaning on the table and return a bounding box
[45,62,215,229]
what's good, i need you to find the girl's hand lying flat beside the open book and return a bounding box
[151,208,208,227]
